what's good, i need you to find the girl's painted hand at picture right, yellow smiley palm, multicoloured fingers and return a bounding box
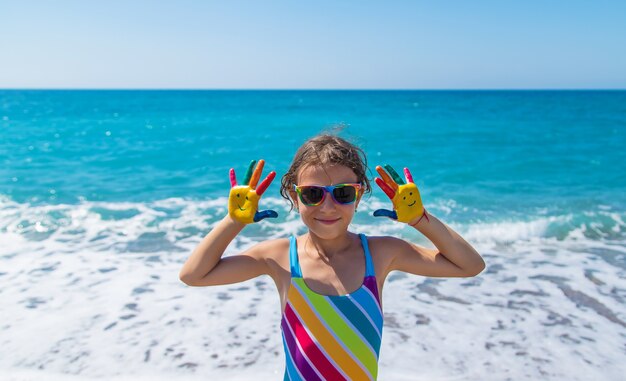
[374,164,428,224]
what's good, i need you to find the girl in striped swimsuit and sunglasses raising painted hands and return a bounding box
[180,135,485,380]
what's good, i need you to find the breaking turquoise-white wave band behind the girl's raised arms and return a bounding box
[0,196,626,253]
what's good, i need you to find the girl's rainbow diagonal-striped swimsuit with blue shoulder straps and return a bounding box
[281,234,383,381]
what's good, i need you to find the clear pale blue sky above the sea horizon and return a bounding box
[0,0,626,89]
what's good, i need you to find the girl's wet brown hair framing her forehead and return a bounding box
[280,134,371,209]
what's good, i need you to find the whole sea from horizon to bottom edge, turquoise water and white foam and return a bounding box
[0,90,626,381]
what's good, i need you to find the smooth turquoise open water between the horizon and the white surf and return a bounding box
[0,91,626,238]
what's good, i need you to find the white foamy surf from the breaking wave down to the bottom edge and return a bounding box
[0,198,626,380]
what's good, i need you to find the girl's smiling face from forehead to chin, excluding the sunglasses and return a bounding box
[291,165,361,239]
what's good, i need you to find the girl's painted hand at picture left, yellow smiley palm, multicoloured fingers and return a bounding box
[228,160,278,224]
